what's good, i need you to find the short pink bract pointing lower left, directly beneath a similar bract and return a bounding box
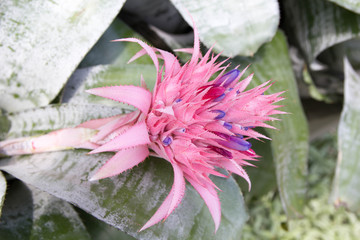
[90,145,149,181]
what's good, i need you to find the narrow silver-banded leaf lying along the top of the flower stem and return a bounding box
[2,104,126,138]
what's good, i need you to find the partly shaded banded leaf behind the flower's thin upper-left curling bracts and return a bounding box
[61,19,156,109]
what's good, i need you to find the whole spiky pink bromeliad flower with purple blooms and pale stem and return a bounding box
[0,23,283,231]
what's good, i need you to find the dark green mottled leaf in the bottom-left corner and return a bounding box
[0,181,90,240]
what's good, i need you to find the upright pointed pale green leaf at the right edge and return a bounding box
[331,59,360,212]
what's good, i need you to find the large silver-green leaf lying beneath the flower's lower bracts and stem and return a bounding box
[0,150,247,239]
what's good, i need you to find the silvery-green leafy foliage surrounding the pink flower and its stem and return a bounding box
[0,0,360,239]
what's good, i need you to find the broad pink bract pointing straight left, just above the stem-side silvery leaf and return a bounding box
[86,86,151,114]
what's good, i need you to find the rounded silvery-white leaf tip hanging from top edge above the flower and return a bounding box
[171,0,280,57]
